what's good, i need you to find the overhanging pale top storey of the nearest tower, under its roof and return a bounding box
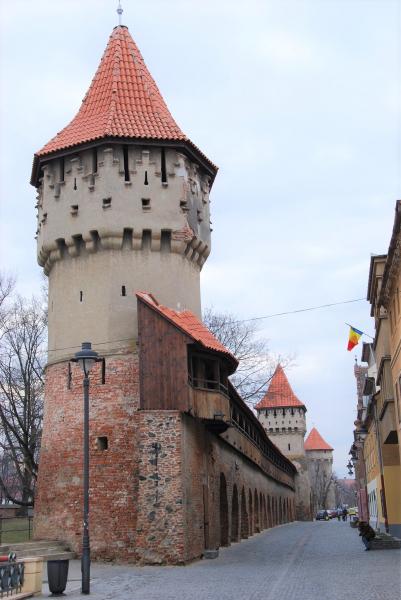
[37,144,211,274]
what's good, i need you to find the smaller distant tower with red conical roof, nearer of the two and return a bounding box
[255,365,311,521]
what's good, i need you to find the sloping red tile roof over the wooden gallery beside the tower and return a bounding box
[136,292,238,365]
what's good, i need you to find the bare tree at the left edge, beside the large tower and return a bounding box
[0,283,46,507]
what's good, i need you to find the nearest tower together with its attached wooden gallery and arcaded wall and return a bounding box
[32,16,296,564]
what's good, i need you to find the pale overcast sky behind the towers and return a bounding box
[0,0,401,476]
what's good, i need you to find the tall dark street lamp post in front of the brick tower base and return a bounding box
[72,342,101,594]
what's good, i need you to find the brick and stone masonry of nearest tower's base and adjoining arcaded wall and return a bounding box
[34,354,295,564]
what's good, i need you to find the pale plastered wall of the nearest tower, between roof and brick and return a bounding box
[37,144,211,362]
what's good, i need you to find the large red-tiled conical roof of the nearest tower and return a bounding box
[32,25,217,182]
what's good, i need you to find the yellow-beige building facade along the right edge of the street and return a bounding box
[363,201,401,537]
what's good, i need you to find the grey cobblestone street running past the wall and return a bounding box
[42,521,401,600]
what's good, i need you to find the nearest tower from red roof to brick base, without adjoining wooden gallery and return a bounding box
[31,26,217,559]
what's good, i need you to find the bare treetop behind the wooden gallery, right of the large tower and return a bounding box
[203,308,293,406]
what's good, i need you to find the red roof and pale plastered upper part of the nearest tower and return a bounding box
[32,26,216,364]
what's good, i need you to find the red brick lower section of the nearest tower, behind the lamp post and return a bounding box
[34,354,139,559]
